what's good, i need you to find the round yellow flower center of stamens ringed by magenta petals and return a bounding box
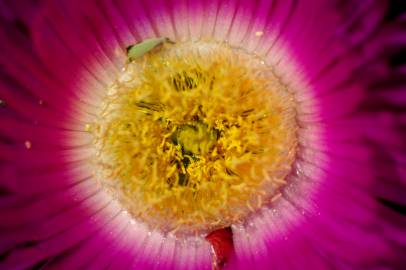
[90,43,297,234]
